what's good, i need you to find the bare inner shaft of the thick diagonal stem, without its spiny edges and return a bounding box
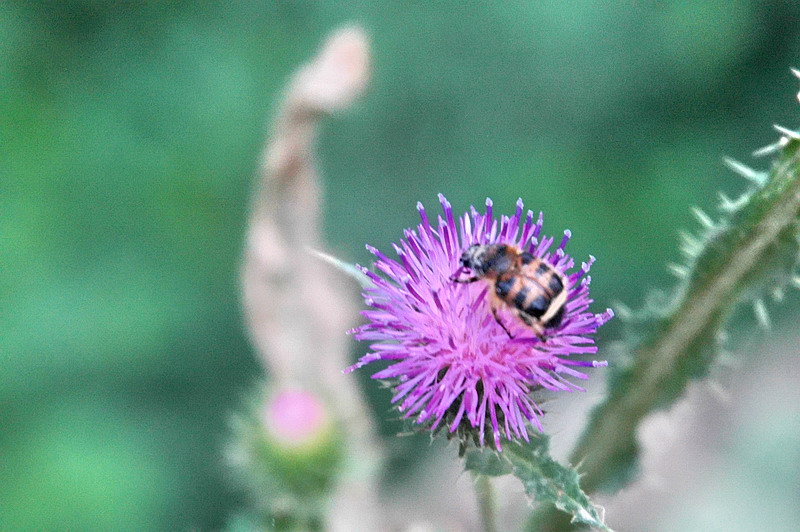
[572,140,800,491]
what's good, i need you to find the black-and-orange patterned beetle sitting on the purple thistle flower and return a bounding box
[450,244,567,338]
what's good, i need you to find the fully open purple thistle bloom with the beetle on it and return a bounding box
[346,194,613,449]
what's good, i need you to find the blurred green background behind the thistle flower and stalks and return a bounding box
[0,0,800,530]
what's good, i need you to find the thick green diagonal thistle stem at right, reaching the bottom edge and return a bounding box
[528,141,800,532]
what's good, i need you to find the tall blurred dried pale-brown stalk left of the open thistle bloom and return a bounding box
[242,27,380,530]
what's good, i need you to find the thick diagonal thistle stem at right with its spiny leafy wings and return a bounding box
[528,119,800,524]
